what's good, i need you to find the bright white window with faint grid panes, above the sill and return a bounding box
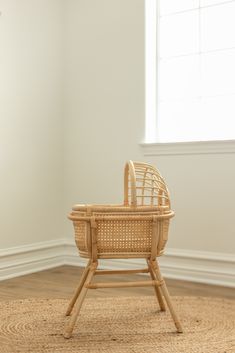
[145,0,235,142]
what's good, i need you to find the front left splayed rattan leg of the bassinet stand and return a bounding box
[64,263,97,338]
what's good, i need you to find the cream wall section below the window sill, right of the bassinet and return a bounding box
[147,153,235,254]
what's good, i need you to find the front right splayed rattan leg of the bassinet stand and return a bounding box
[150,260,183,333]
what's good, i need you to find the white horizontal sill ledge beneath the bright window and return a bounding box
[140,140,235,156]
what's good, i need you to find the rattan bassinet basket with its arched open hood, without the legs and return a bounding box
[69,161,174,258]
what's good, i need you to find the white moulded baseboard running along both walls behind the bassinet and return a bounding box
[0,239,235,287]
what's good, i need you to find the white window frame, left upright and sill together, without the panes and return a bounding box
[144,0,235,151]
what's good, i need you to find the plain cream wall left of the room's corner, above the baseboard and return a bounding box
[0,0,63,249]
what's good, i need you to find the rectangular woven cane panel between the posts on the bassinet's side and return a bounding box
[97,220,152,253]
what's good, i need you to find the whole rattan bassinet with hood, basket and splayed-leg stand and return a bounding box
[64,161,182,338]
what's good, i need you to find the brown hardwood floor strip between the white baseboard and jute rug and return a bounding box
[0,266,235,300]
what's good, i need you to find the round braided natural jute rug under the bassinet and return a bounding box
[0,296,235,353]
